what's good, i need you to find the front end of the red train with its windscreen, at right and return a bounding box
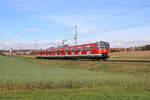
[96,41,110,60]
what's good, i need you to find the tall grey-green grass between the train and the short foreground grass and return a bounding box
[0,56,150,91]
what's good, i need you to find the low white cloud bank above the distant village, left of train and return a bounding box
[0,40,62,50]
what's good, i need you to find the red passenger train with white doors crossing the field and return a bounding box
[36,41,110,60]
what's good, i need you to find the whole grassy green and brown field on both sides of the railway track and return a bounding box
[0,52,150,100]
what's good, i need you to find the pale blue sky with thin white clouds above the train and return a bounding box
[0,0,150,48]
